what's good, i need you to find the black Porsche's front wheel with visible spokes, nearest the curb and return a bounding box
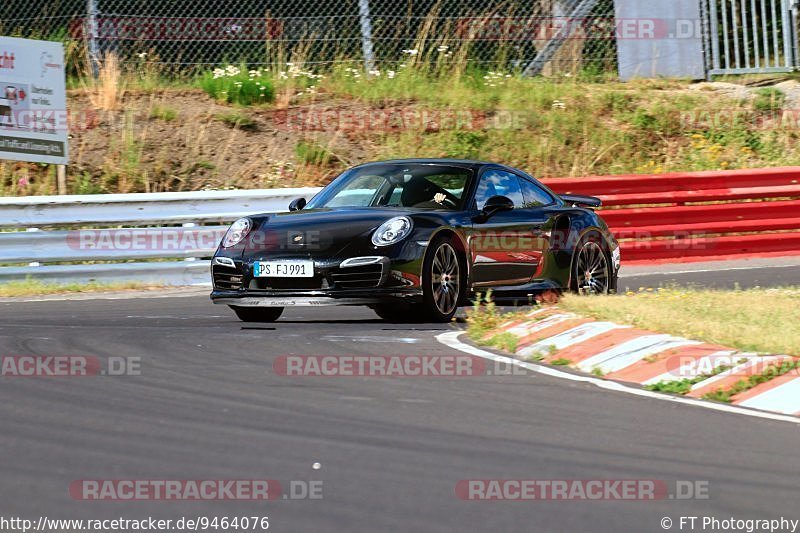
[422,238,464,322]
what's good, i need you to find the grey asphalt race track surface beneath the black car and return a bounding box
[0,266,800,532]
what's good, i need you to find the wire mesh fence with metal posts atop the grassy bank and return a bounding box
[0,0,616,75]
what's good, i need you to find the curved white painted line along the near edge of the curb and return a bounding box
[436,331,800,424]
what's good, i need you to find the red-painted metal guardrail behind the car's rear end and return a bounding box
[545,167,800,262]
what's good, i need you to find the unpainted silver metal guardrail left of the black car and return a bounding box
[0,187,319,285]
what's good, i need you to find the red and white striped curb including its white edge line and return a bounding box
[437,308,800,423]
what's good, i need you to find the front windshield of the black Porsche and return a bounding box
[307,163,472,210]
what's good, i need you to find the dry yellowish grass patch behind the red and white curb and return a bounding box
[559,287,800,356]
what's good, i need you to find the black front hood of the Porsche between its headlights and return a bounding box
[244,208,407,257]
